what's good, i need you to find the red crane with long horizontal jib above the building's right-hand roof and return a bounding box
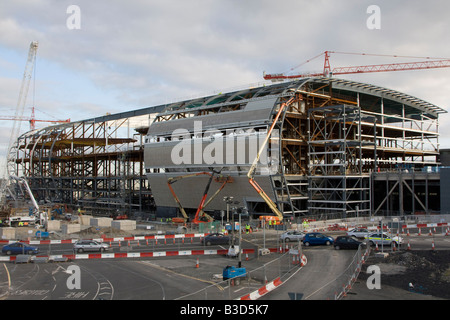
[264,51,450,81]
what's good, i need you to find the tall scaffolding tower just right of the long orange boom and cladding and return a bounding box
[308,104,376,215]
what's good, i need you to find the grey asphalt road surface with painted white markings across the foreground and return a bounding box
[0,230,450,300]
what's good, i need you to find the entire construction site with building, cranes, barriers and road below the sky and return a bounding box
[0,42,450,300]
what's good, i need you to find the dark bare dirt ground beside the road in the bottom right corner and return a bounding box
[356,250,450,299]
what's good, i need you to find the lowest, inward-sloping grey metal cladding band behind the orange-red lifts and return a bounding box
[147,173,275,210]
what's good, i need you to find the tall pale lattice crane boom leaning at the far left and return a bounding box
[0,41,38,204]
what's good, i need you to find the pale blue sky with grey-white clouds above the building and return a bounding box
[0,0,450,162]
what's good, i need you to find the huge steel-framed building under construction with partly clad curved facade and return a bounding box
[9,77,446,217]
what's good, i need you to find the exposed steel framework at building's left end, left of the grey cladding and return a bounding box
[14,118,154,216]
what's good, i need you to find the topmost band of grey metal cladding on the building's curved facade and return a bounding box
[148,98,278,136]
